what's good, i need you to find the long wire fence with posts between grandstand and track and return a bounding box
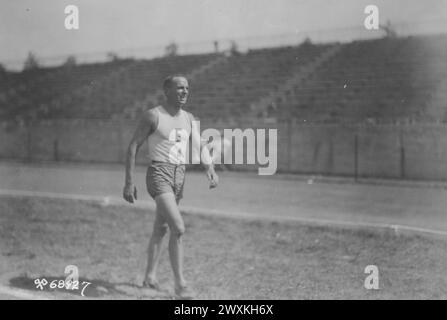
[0,120,447,181]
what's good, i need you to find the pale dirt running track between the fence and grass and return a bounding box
[0,162,447,234]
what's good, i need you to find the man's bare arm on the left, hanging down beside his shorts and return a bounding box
[123,110,158,203]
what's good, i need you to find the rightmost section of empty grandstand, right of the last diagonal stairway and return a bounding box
[276,36,447,123]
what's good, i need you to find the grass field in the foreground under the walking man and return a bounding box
[0,196,447,299]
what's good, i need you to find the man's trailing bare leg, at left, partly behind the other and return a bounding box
[144,206,168,288]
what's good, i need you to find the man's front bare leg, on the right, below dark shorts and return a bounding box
[155,193,192,292]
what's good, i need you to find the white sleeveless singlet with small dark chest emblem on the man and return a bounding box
[148,106,191,164]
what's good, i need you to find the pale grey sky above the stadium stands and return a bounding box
[0,0,447,66]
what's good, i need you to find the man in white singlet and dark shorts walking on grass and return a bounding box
[123,75,218,299]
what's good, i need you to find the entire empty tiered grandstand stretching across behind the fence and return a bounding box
[0,35,447,123]
